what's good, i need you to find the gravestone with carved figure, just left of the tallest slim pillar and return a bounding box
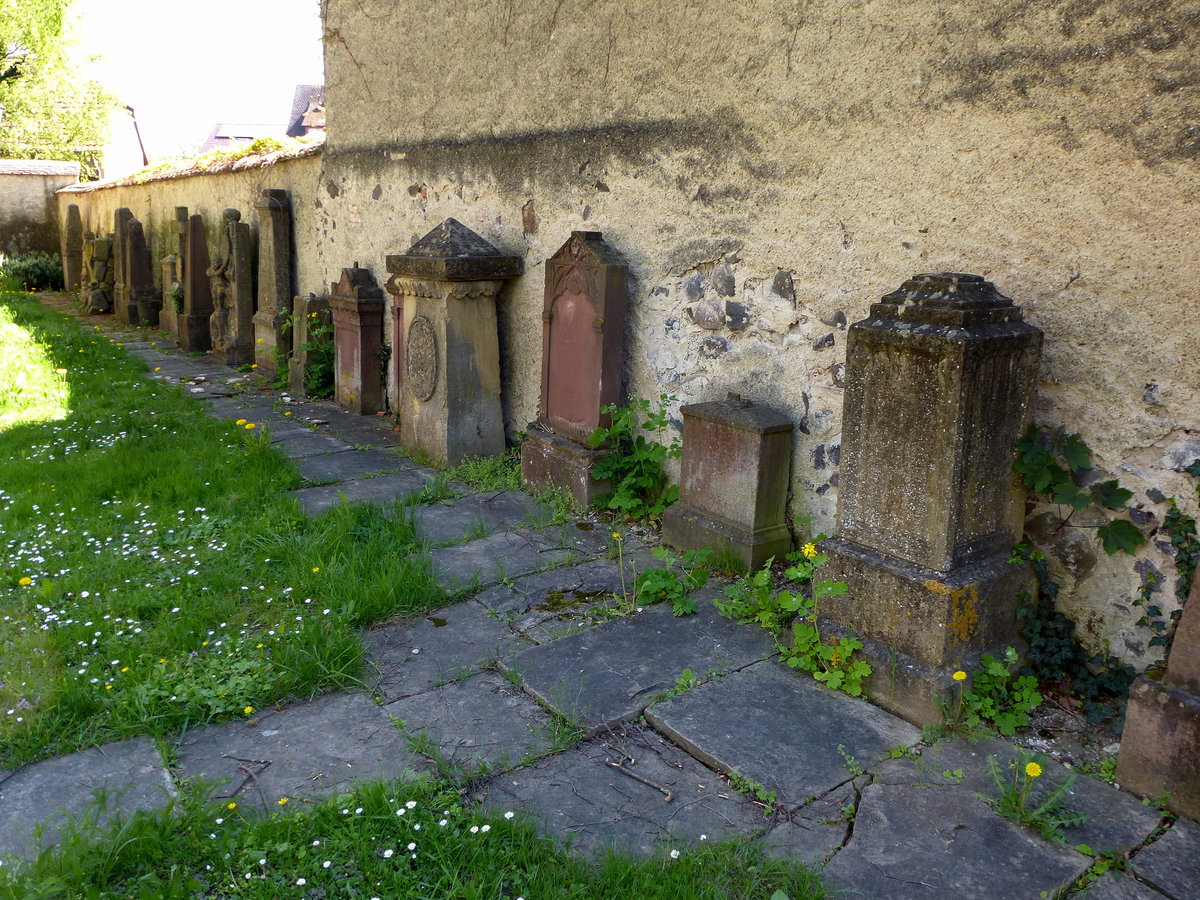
[206,209,254,366]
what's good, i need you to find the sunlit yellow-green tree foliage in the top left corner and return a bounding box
[0,0,114,178]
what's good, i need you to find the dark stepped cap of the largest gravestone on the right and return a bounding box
[871,272,1021,325]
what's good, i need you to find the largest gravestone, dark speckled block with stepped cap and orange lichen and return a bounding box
[818,274,1042,725]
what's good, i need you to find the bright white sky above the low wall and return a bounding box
[73,0,325,168]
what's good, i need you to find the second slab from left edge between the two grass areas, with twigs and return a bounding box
[178,691,420,812]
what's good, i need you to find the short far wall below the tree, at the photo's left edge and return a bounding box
[0,160,79,256]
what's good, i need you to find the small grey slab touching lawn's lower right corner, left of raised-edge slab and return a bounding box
[385,672,556,773]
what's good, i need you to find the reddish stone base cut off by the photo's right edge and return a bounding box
[1116,676,1200,820]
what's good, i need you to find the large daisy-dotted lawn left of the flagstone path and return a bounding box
[0,293,444,768]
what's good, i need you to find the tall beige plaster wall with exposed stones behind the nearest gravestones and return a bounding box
[316,0,1200,659]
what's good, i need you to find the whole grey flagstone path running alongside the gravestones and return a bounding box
[0,300,1200,900]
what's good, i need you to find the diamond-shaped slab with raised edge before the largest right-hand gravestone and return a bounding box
[648,657,920,808]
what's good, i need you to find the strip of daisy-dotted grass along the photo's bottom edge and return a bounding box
[0,780,824,900]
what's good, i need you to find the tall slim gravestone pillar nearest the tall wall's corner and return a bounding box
[254,187,293,378]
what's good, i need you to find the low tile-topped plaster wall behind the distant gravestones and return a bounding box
[58,150,329,301]
